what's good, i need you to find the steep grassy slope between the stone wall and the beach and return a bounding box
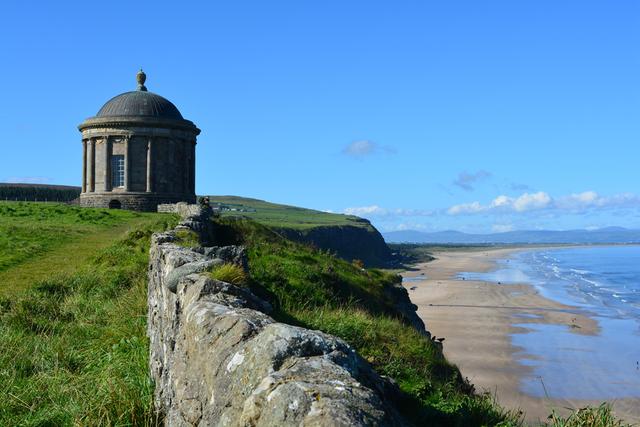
[218,218,519,426]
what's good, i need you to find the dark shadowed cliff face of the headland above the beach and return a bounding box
[276,218,392,267]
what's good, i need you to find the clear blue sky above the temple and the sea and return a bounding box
[0,0,640,232]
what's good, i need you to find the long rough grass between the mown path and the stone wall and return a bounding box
[0,216,175,426]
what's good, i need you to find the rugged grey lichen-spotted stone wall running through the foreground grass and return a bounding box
[148,206,405,426]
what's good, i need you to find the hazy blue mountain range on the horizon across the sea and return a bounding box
[382,227,640,244]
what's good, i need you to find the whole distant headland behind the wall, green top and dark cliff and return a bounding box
[209,196,392,267]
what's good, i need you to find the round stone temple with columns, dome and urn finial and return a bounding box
[78,70,200,211]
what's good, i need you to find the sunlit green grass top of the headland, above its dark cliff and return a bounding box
[209,196,371,230]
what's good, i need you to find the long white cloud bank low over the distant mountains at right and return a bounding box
[447,191,640,215]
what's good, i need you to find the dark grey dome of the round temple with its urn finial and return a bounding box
[96,70,184,120]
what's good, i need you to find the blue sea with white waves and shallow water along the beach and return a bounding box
[461,246,640,400]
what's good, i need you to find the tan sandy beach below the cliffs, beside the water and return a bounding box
[403,249,640,423]
